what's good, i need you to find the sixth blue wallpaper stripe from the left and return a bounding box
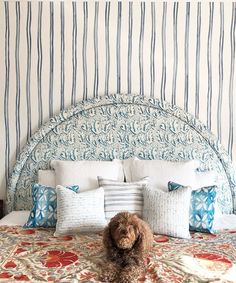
[60,1,65,110]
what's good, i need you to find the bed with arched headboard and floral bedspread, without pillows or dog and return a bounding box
[0,94,236,283]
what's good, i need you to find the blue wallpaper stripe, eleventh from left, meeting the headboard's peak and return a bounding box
[116,2,122,93]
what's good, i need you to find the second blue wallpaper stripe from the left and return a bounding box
[15,2,21,158]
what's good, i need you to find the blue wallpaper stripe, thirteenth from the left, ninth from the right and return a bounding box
[139,2,145,95]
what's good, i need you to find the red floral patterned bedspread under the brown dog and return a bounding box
[0,226,236,283]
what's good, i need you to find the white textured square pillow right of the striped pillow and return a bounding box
[143,187,191,239]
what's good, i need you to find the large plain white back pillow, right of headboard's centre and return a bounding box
[123,158,198,191]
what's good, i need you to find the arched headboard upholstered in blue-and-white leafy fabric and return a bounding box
[7,94,236,213]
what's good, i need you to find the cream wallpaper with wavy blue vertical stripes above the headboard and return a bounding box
[0,1,236,198]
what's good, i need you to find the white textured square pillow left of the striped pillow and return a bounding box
[55,186,107,236]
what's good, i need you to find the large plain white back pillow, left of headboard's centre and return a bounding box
[51,160,124,192]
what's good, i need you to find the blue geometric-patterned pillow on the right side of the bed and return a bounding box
[168,182,216,233]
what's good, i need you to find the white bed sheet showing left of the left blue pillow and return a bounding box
[0,210,30,226]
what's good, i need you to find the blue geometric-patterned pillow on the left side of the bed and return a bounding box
[23,184,79,228]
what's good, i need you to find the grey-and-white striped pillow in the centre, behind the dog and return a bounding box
[98,176,149,221]
